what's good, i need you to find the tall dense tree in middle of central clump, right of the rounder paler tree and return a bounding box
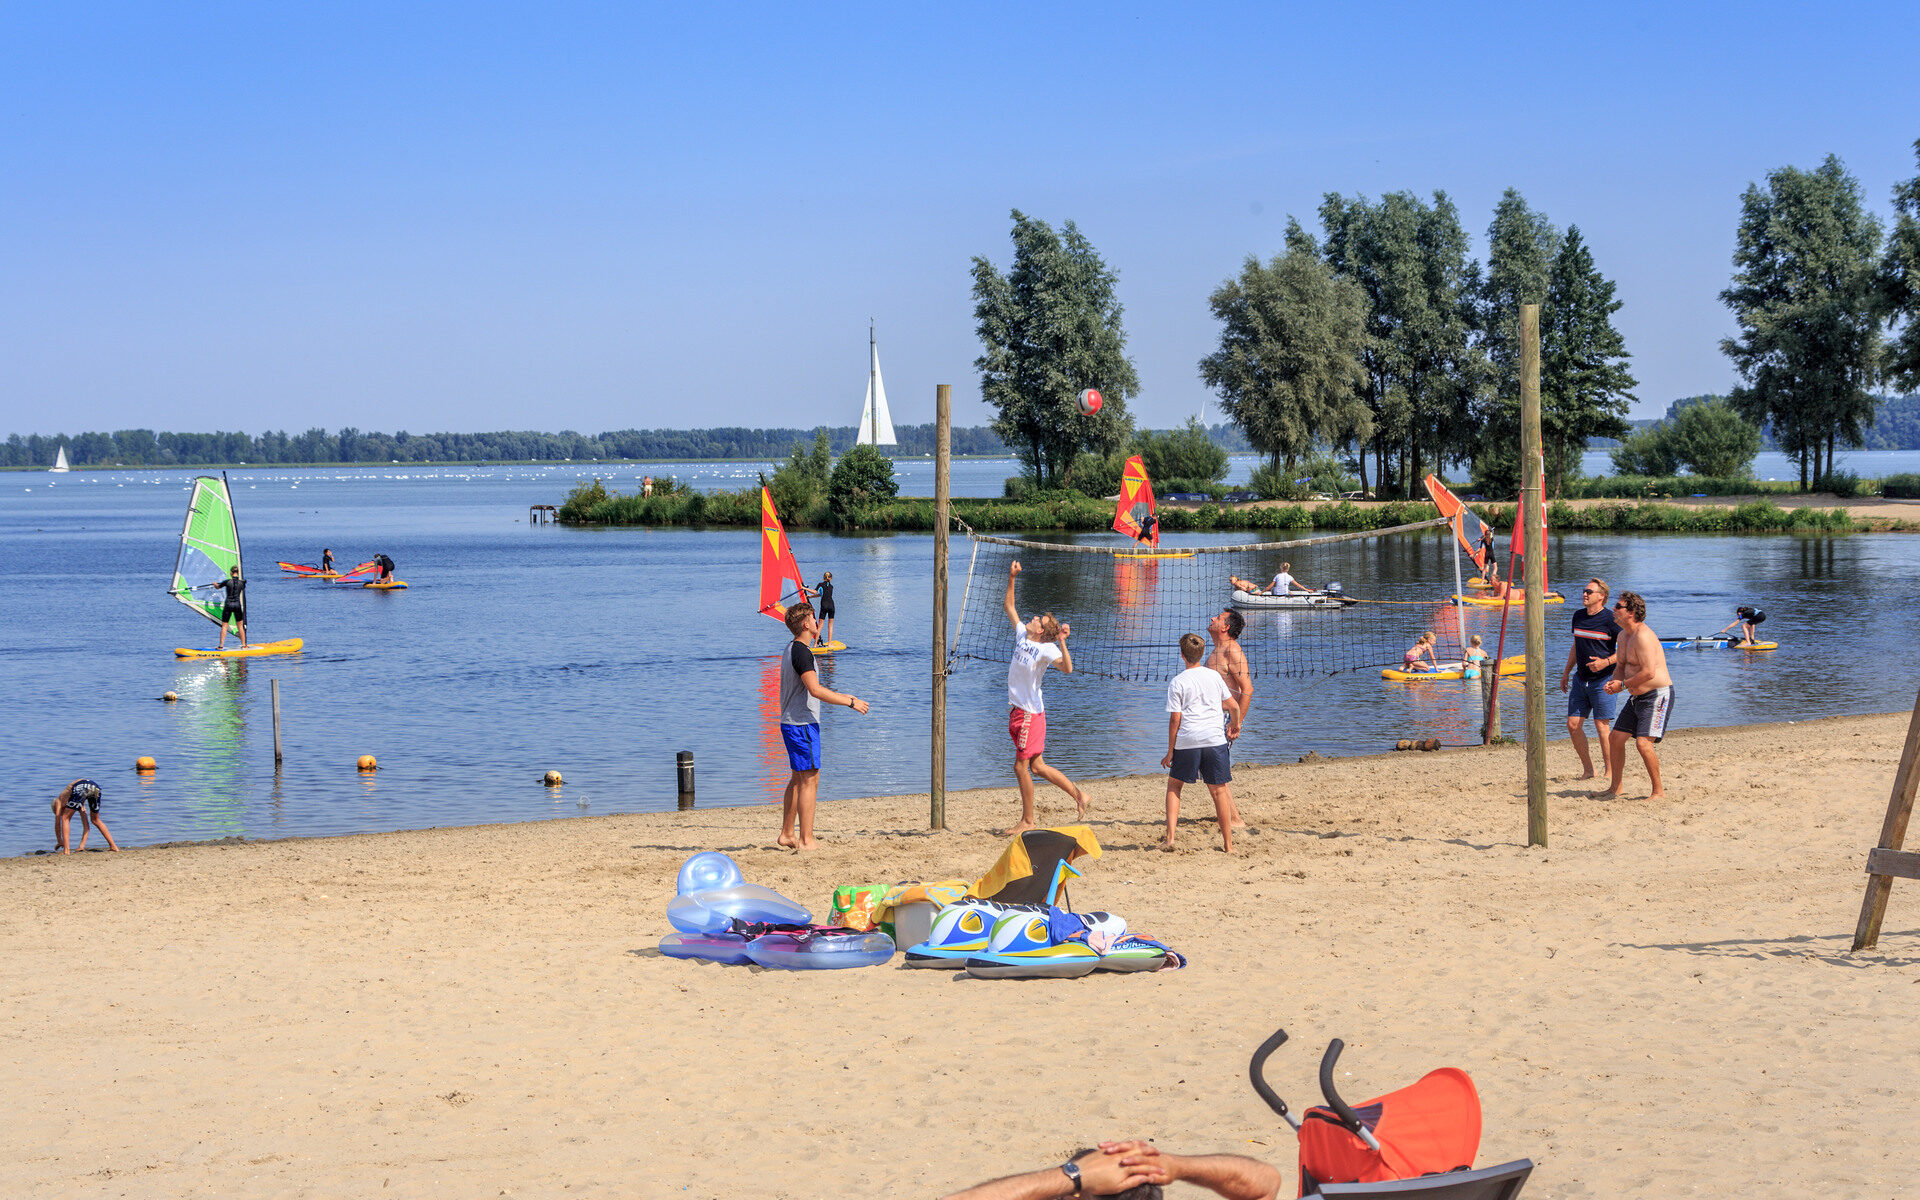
[1320,192,1486,497]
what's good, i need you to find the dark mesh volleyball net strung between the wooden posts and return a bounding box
[948,518,1500,680]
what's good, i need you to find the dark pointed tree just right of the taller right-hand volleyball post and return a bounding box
[1528,225,1634,495]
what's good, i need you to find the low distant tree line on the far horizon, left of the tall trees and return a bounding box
[0,422,1006,467]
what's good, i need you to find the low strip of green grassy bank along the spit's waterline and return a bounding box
[561,486,1862,534]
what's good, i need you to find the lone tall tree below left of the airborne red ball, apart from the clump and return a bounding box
[973,209,1140,488]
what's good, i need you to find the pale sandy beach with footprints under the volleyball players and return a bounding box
[0,714,1920,1196]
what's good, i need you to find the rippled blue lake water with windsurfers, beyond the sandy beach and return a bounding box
[0,461,1920,854]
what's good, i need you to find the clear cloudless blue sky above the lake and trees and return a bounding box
[0,4,1920,434]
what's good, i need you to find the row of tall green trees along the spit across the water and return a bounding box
[973,142,1920,497]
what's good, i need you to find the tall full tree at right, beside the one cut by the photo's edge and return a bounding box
[1720,154,1884,492]
